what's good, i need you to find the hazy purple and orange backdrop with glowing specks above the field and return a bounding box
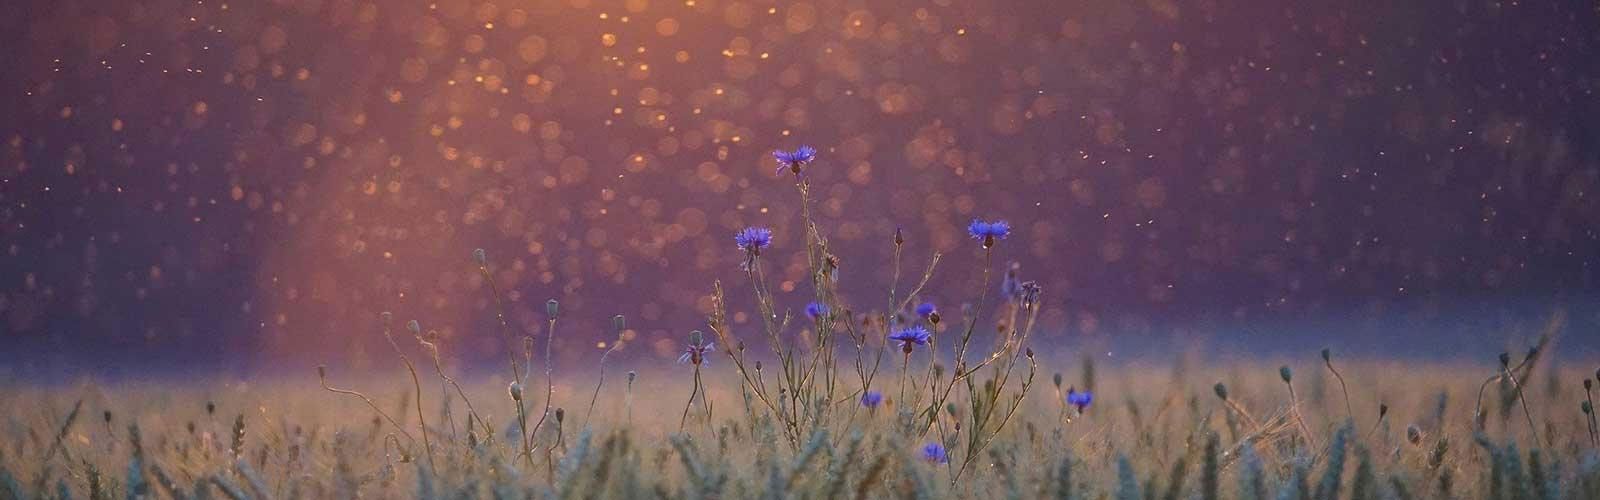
[0,0,1600,375]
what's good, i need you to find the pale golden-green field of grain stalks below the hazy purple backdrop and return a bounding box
[0,357,1600,498]
